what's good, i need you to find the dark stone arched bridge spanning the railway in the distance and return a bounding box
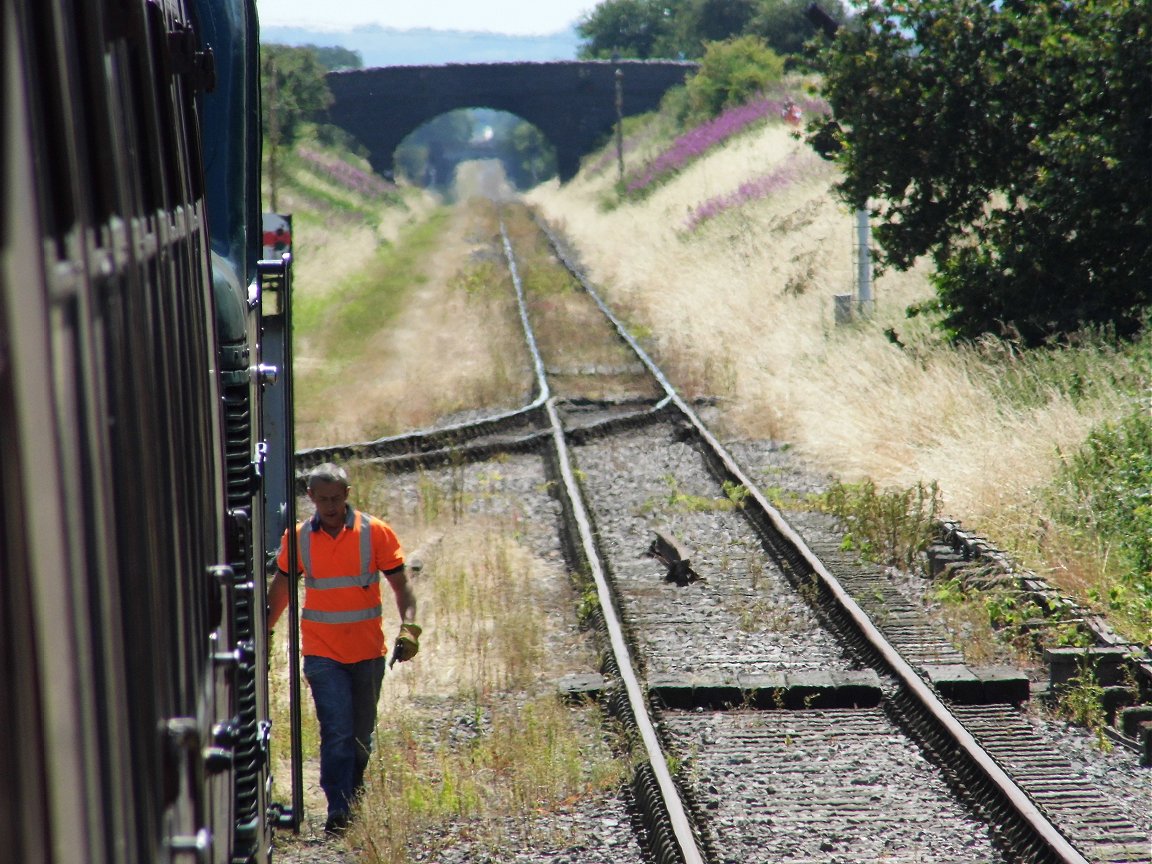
[327,60,697,181]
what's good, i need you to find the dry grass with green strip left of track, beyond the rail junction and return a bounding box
[296,204,531,447]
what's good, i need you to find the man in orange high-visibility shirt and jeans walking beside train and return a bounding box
[268,462,420,834]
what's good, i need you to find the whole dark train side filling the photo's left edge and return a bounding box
[0,0,288,864]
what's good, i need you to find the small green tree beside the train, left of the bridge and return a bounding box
[260,45,332,211]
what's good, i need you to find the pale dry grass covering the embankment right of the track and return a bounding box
[528,115,1127,599]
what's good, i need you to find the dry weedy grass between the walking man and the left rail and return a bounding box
[272,465,623,864]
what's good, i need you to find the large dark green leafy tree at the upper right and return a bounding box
[810,0,1152,344]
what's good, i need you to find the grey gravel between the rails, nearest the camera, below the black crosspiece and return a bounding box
[664,708,1000,864]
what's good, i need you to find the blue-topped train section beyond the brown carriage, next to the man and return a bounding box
[194,0,283,862]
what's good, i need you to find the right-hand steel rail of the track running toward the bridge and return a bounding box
[537,220,1089,864]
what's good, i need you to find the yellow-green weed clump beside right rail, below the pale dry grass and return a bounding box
[817,480,941,568]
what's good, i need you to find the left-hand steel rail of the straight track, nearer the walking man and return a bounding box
[500,220,705,864]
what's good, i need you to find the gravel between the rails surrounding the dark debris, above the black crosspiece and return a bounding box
[576,425,855,680]
